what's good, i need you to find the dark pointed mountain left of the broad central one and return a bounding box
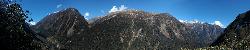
[34,8,88,50]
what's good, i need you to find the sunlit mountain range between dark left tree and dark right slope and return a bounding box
[32,8,224,50]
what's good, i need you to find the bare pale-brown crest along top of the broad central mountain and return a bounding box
[94,9,174,20]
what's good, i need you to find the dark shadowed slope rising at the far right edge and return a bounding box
[213,11,250,48]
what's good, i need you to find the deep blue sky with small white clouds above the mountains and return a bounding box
[19,0,250,27]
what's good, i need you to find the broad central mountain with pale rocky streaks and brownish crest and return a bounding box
[89,11,193,50]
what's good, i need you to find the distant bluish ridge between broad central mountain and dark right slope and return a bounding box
[184,23,224,47]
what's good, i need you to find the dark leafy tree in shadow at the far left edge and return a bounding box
[0,0,42,50]
